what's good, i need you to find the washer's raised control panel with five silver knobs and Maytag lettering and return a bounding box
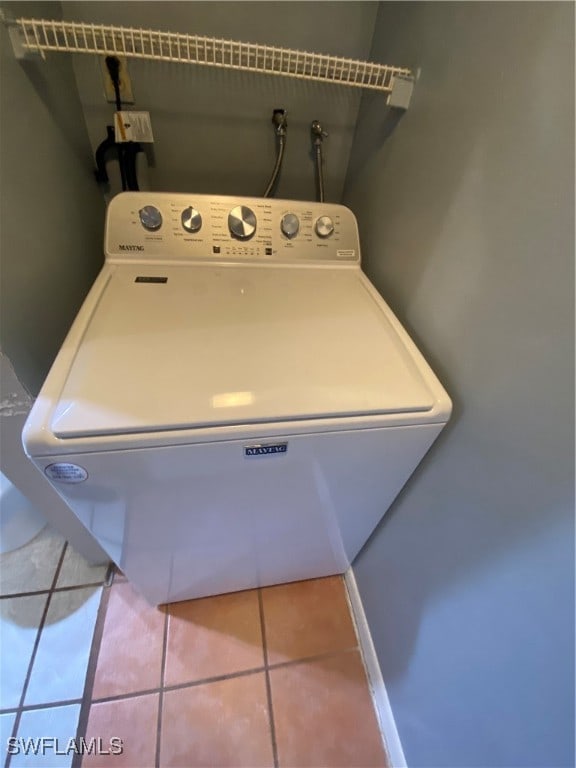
[105,192,360,264]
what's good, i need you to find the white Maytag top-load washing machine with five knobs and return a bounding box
[23,192,451,604]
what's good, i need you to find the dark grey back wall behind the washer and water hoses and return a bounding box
[64,0,378,202]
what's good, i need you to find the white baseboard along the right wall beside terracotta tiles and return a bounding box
[344,568,407,768]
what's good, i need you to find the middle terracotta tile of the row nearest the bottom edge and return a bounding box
[160,672,274,768]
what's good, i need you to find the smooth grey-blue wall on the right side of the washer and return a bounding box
[344,2,574,768]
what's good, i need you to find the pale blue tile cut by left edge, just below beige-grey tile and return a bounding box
[0,595,48,709]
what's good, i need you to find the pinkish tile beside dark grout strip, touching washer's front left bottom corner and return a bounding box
[92,582,165,699]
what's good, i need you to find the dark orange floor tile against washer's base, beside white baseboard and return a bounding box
[262,576,357,664]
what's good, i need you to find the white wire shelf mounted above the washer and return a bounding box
[15,18,412,93]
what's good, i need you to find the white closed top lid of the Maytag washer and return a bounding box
[51,265,435,438]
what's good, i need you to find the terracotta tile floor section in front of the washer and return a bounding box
[80,574,387,768]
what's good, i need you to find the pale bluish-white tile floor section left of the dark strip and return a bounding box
[0,526,108,768]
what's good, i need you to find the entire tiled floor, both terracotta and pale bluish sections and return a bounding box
[0,529,387,768]
